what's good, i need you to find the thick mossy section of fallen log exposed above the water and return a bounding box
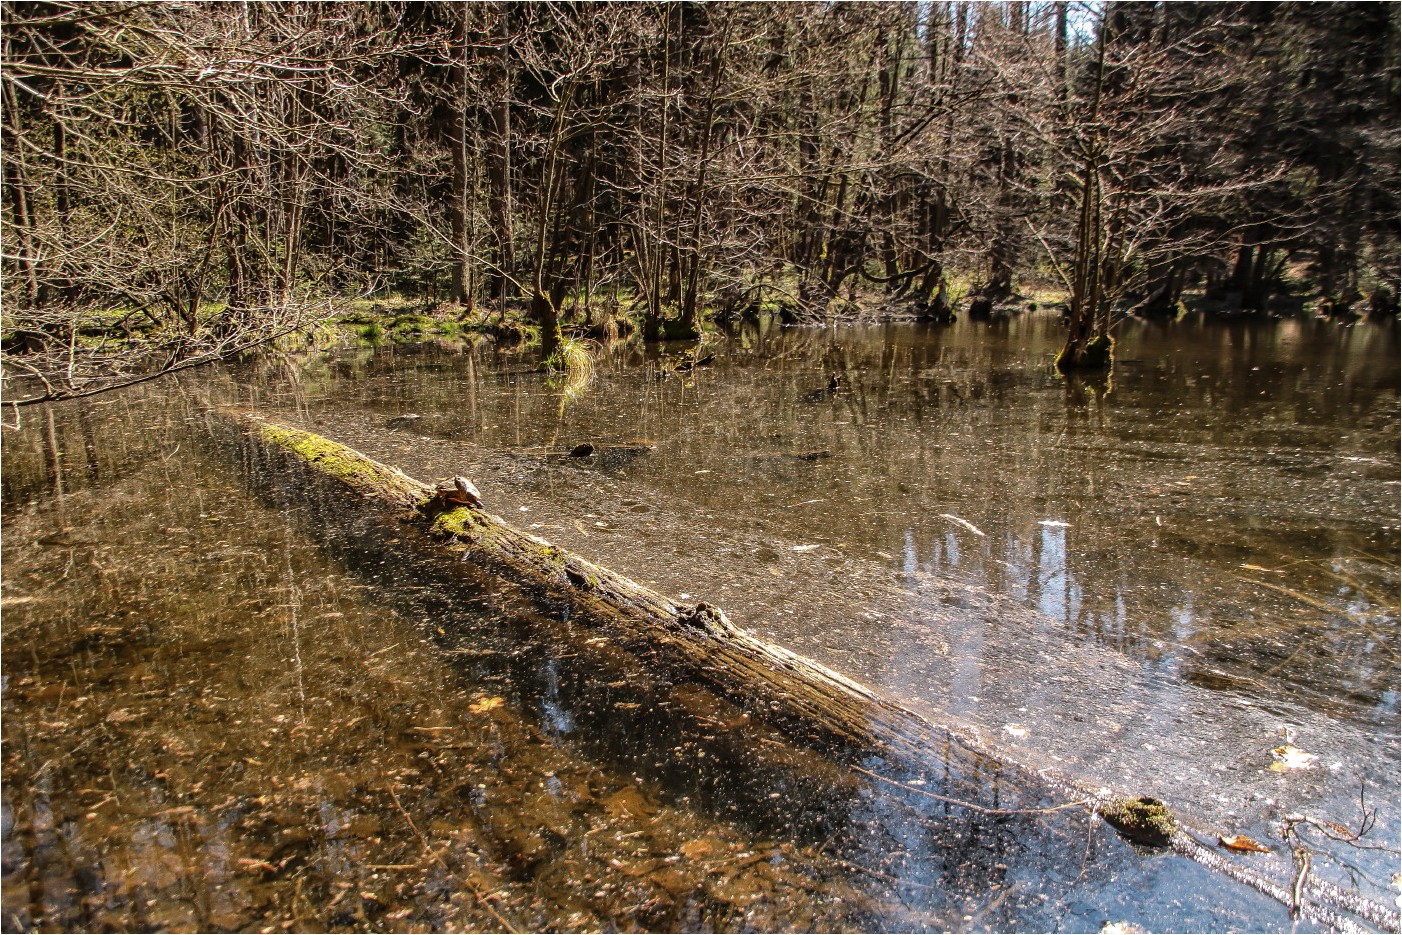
[210,408,949,761]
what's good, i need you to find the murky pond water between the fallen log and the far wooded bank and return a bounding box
[298,314,1399,869]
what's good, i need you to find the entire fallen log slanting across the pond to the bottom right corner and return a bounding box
[215,408,1399,931]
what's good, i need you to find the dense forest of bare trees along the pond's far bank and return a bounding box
[0,1,1399,402]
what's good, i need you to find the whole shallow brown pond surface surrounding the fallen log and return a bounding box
[4,315,1398,931]
